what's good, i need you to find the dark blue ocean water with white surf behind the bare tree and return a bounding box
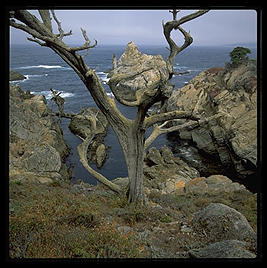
[10,44,256,184]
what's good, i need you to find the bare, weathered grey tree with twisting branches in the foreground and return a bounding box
[10,9,208,203]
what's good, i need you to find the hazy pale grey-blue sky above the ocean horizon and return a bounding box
[10,10,257,46]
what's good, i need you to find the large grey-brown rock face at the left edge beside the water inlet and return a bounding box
[9,85,69,183]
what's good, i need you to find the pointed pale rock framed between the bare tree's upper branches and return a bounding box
[108,42,169,101]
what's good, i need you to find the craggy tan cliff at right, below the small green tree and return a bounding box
[167,60,257,178]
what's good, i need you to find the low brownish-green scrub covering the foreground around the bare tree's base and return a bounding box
[9,177,257,258]
